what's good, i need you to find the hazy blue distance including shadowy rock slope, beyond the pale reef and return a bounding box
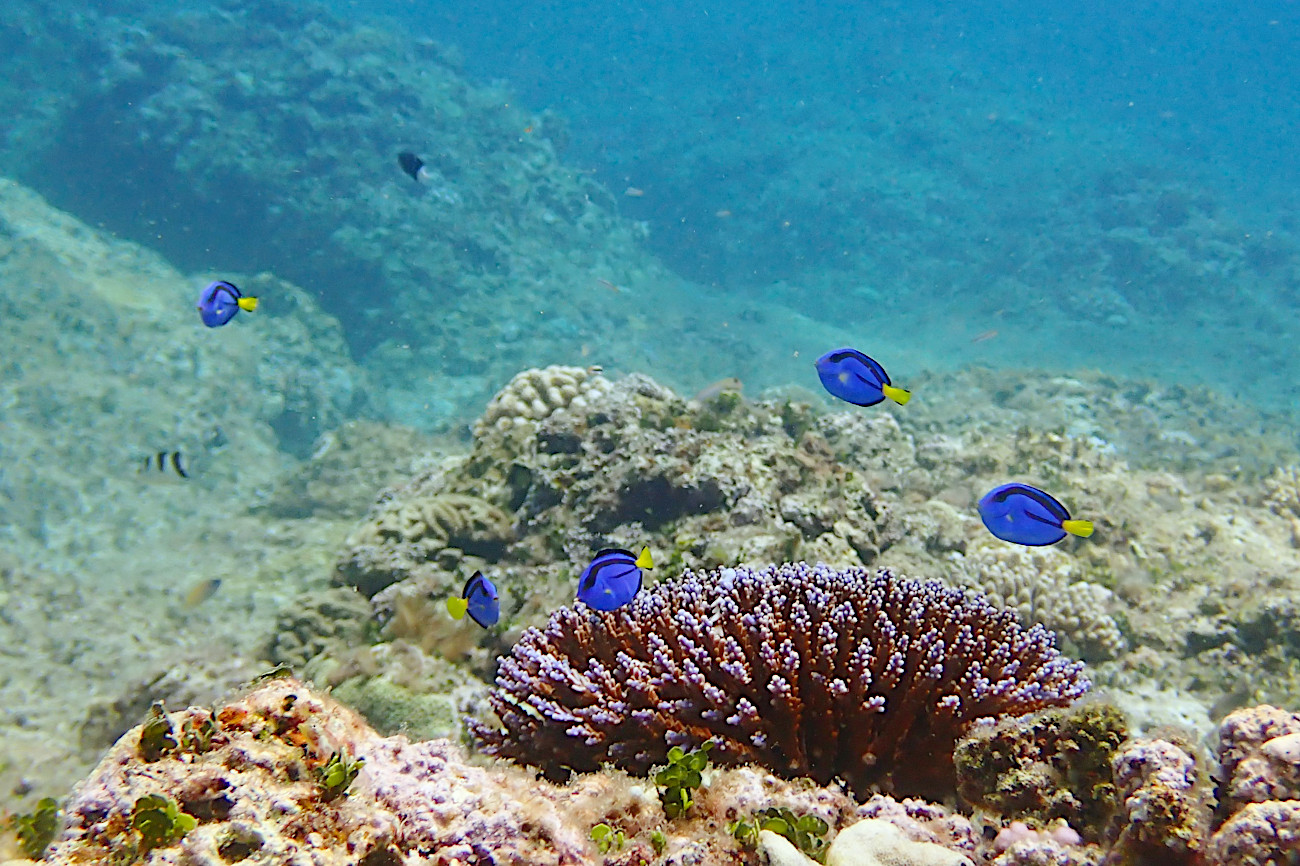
[5,3,1300,426]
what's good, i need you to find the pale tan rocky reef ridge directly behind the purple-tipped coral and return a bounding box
[327,368,1300,731]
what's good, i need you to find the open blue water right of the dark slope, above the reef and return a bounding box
[325,3,1300,407]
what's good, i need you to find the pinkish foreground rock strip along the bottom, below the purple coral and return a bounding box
[16,677,1297,866]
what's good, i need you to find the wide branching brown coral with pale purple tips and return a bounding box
[475,563,1088,793]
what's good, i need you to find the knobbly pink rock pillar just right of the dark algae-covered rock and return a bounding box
[1113,740,1210,865]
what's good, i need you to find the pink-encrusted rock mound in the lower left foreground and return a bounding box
[47,679,662,866]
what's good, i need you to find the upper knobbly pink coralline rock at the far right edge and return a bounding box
[1218,705,1300,818]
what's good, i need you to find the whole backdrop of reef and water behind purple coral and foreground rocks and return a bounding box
[0,0,1300,858]
